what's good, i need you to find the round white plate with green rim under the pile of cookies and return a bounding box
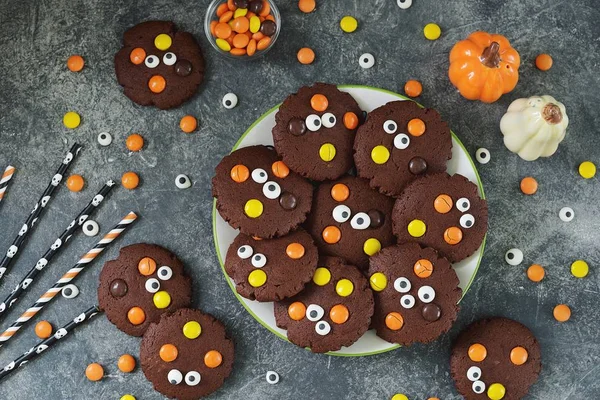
[213,85,485,356]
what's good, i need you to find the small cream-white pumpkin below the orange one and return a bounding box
[500,96,569,161]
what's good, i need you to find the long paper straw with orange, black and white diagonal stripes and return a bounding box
[0,212,137,347]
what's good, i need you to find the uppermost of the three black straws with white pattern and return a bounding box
[0,143,81,281]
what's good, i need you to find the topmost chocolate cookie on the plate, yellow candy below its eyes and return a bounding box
[273,83,362,181]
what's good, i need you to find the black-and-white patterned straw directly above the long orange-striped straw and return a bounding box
[0,180,115,320]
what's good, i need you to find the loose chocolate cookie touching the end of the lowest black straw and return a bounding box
[98,243,192,336]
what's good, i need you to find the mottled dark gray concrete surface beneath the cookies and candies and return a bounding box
[0,0,600,400]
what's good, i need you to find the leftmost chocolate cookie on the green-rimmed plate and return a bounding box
[212,146,313,238]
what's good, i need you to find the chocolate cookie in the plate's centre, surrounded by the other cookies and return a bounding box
[306,176,394,270]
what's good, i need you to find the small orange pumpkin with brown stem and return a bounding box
[448,32,521,103]
